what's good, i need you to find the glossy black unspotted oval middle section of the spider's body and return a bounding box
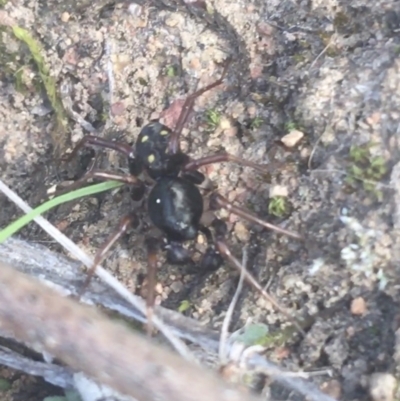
[147,177,203,241]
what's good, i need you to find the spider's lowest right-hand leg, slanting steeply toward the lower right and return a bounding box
[212,219,305,334]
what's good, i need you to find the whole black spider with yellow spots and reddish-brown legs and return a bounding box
[63,62,300,324]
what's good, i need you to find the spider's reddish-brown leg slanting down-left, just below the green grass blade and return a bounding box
[78,214,139,299]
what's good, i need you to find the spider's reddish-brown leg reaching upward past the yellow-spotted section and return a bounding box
[168,61,230,154]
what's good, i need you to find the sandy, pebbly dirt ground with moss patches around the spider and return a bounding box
[0,0,400,400]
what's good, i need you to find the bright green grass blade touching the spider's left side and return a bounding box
[0,181,124,243]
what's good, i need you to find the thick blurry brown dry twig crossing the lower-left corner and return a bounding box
[0,263,257,401]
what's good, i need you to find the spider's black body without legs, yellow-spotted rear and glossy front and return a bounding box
[133,121,208,260]
